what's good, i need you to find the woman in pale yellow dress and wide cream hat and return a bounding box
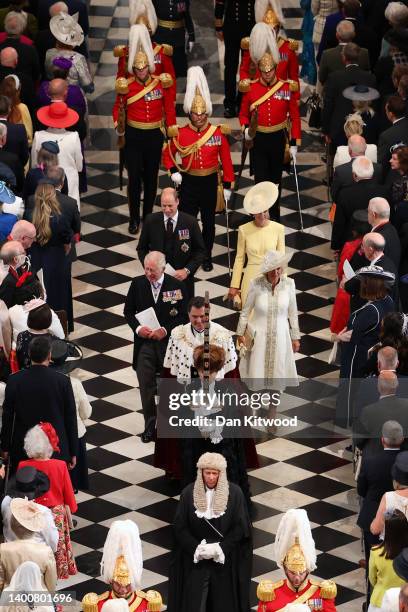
[228,181,285,306]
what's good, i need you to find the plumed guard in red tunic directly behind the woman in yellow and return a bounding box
[239,24,301,221]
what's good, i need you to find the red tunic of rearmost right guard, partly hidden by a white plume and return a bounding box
[239,38,300,99]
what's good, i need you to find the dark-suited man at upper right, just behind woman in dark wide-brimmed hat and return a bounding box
[322,43,376,148]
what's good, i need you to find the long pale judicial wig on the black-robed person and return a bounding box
[193,453,229,515]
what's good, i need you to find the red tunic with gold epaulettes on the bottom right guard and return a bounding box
[258,580,336,612]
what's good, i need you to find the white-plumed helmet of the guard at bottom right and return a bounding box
[275,509,316,572]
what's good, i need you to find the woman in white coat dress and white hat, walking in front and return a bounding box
[237,251,300,391]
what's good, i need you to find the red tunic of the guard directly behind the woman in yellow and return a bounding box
[239,79,301,141]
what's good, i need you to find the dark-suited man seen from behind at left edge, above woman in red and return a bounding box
[0,337,78,470]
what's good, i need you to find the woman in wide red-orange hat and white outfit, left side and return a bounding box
[31,102,84,208]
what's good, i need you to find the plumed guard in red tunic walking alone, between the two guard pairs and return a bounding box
[163,66,234,271]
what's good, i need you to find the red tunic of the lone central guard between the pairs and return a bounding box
[163,123,234,187]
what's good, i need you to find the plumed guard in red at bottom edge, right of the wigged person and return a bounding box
[257,509,337,612]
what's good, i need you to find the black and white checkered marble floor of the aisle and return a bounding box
[61,0,364,612]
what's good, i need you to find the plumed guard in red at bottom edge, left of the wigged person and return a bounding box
[82,520,162,612]
